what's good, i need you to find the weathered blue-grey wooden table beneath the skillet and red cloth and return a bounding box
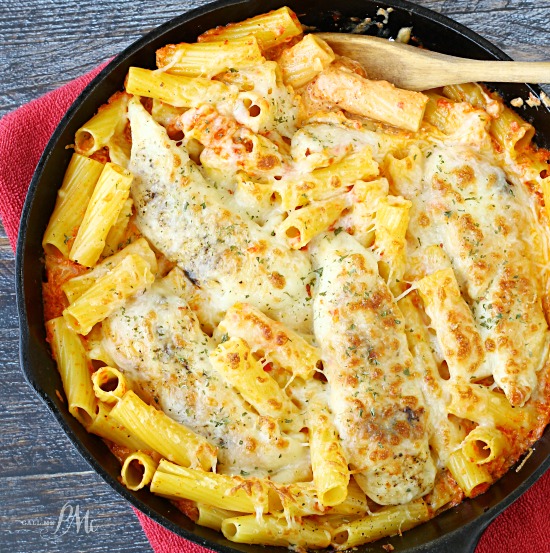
[0,0,550,553]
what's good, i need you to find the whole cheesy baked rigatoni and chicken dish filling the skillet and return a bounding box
[43,8,550,549]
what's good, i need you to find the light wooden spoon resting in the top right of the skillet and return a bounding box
[316,33,550,90]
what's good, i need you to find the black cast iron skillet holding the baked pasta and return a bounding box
[16,0,550,553]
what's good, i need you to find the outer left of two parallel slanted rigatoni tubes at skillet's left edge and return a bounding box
[42,154,103,257]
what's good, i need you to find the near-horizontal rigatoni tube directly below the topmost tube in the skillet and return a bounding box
[157,36,264,78]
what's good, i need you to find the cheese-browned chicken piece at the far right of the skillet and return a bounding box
[409,146,549,405]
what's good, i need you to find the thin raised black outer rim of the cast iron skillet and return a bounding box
[15,0,550,553]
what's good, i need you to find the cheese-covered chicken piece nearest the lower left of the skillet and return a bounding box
[103,275,310,481]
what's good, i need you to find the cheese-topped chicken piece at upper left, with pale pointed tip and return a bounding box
[129,98,311,332]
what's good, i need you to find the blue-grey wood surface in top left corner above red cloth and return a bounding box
[0,0,213,115]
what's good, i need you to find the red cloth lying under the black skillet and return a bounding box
[0,67,550,553]
